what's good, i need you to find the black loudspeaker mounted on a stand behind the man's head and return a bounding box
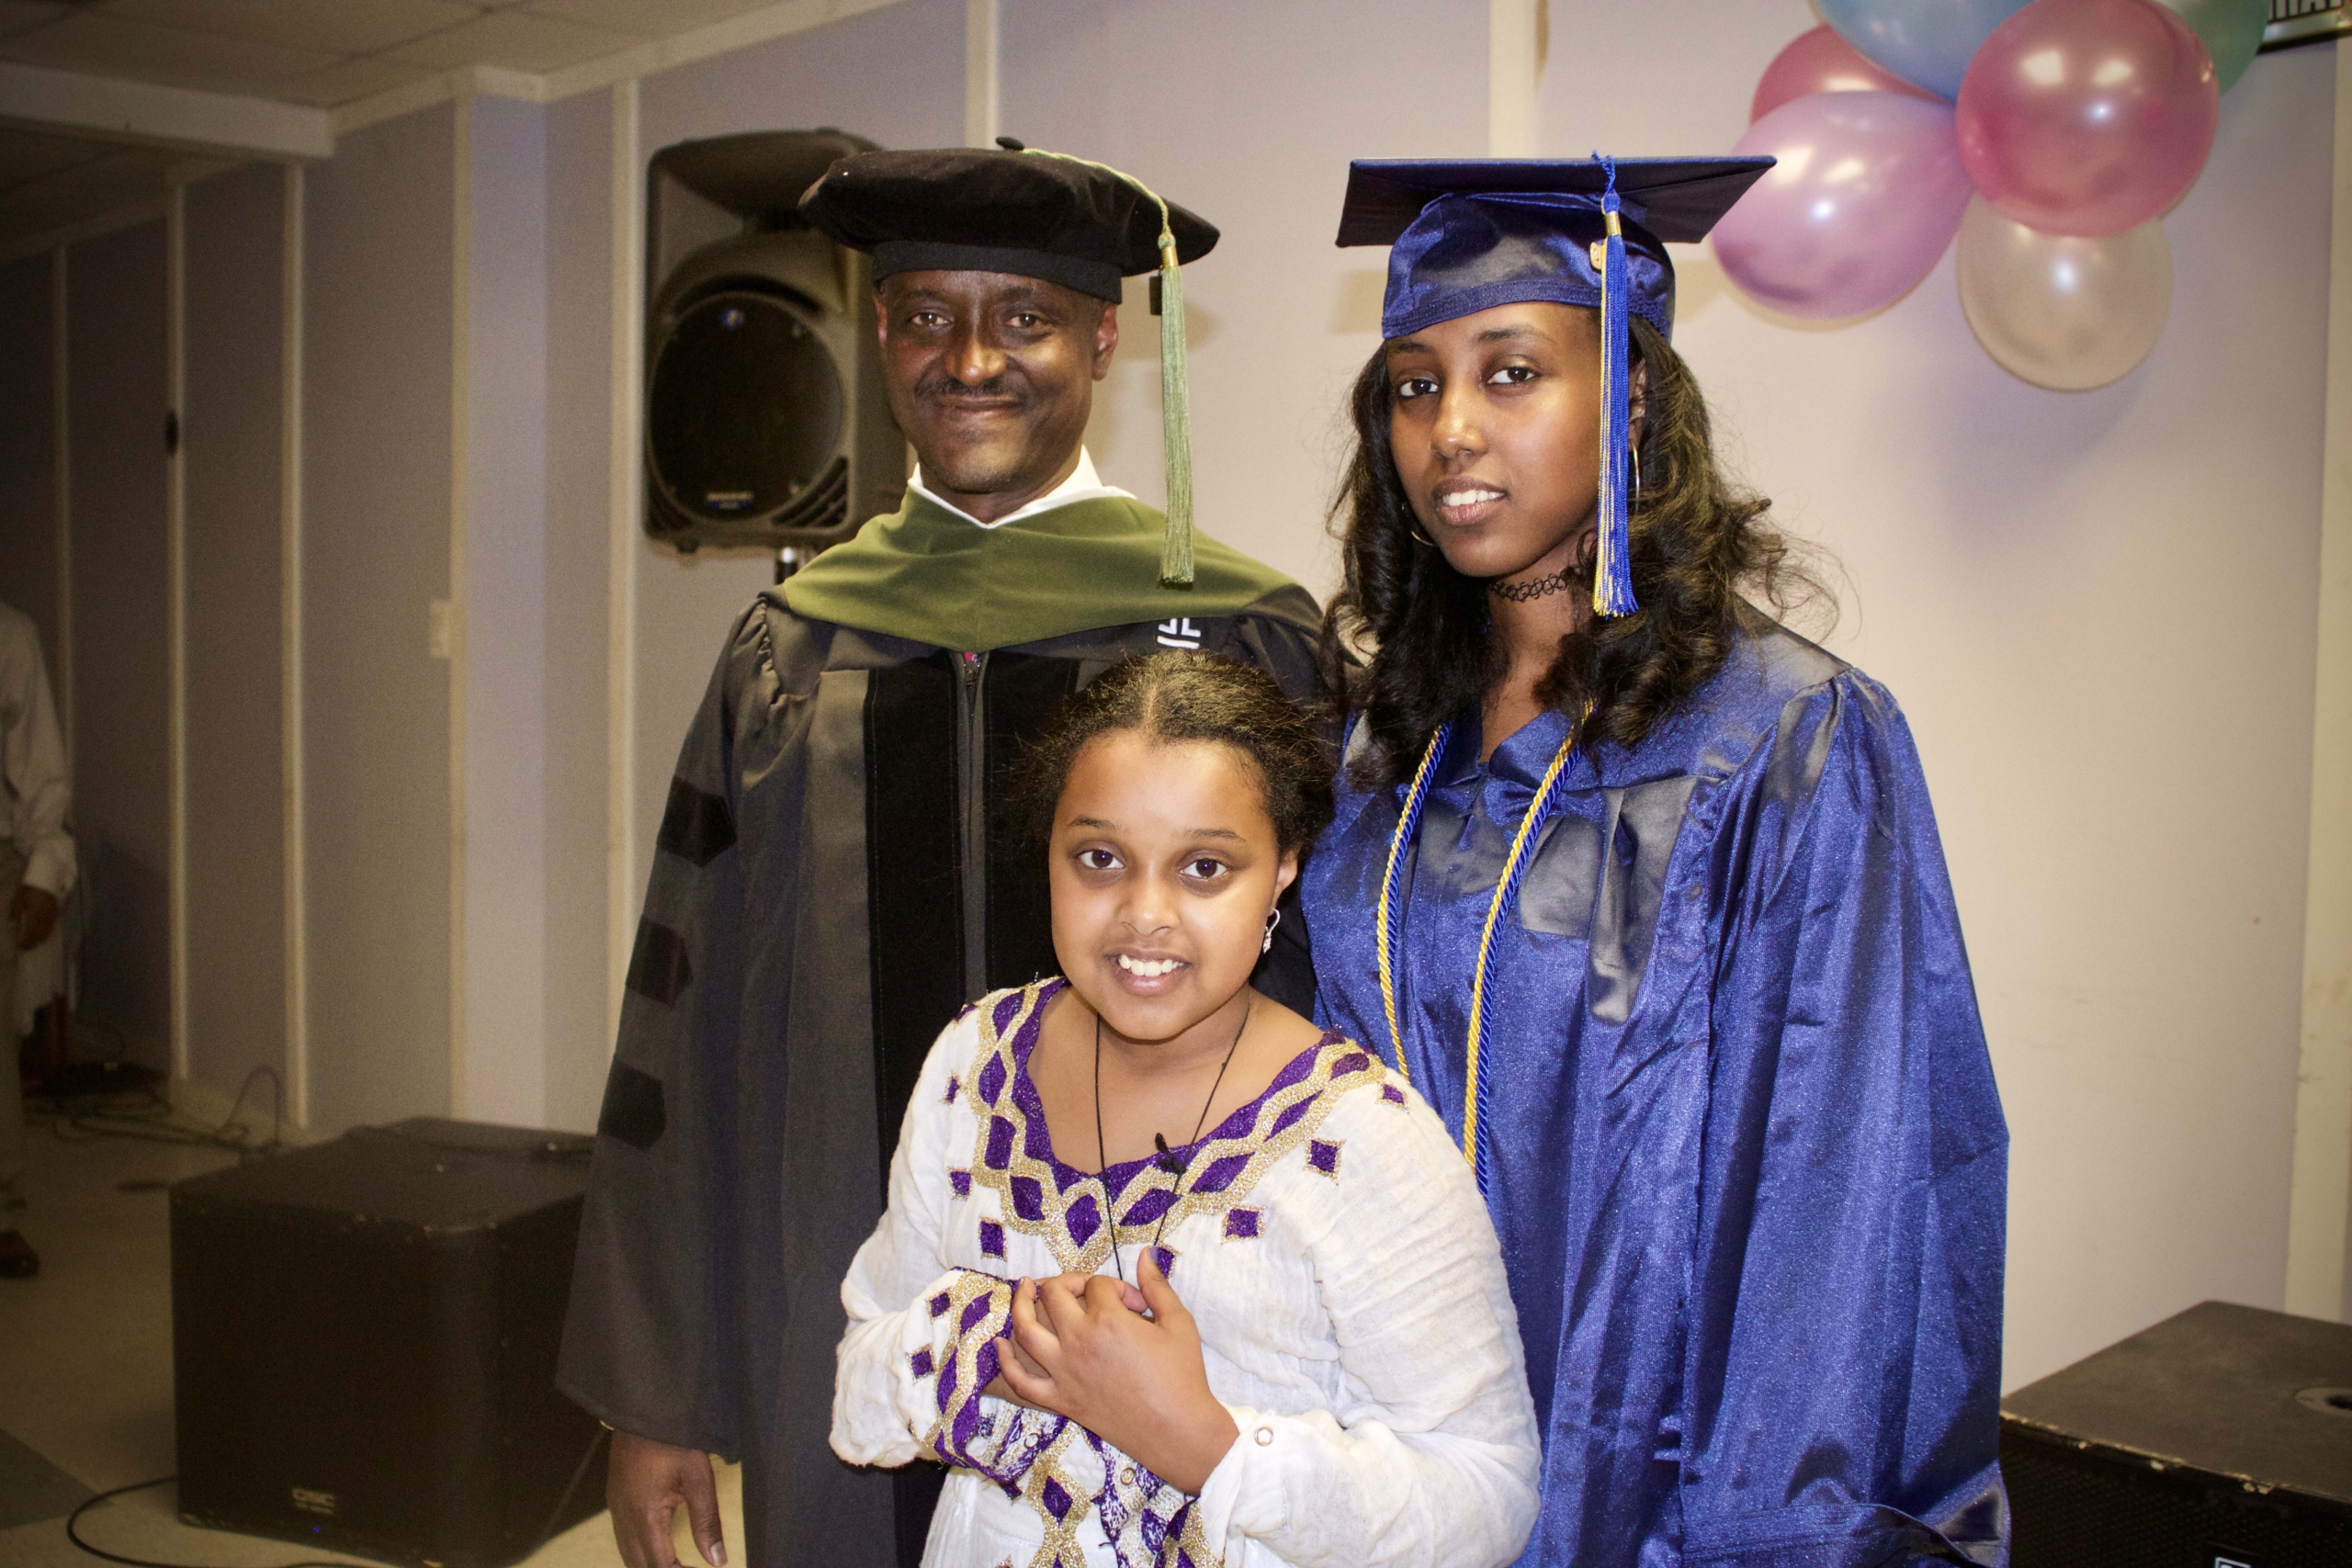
[644,130,906,576]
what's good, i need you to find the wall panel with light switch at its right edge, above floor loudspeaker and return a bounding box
[303,104,457,1131]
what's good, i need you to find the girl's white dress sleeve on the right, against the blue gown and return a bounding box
[1200,1089,1538,1568]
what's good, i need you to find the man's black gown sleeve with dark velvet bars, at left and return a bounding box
[555,606,776,1458]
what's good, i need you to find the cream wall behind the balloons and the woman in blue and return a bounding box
[1541,0,2334,1387]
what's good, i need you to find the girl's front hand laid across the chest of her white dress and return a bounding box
[1000,1251,1239,1495]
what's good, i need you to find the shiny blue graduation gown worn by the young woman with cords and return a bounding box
[1303,618,2008,1568]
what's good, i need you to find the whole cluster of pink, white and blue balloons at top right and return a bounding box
[1714,0,2269,392]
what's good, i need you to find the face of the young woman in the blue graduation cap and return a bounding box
[1387,303,1601,579]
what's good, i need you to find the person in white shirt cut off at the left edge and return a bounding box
[0,604,73,1279]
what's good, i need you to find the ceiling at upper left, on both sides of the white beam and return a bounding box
[0,0,799,252]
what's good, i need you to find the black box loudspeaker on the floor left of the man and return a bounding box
[172,1119,606,1568]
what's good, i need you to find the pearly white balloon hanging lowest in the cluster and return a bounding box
[1959,195,2173,392]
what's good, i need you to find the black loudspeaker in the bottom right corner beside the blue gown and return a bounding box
[2002,1303,2352,1568]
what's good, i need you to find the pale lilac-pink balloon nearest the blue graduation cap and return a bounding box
[1714,92,1969,320]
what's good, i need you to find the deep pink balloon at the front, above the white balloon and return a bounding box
[1957,0,2221,237]
